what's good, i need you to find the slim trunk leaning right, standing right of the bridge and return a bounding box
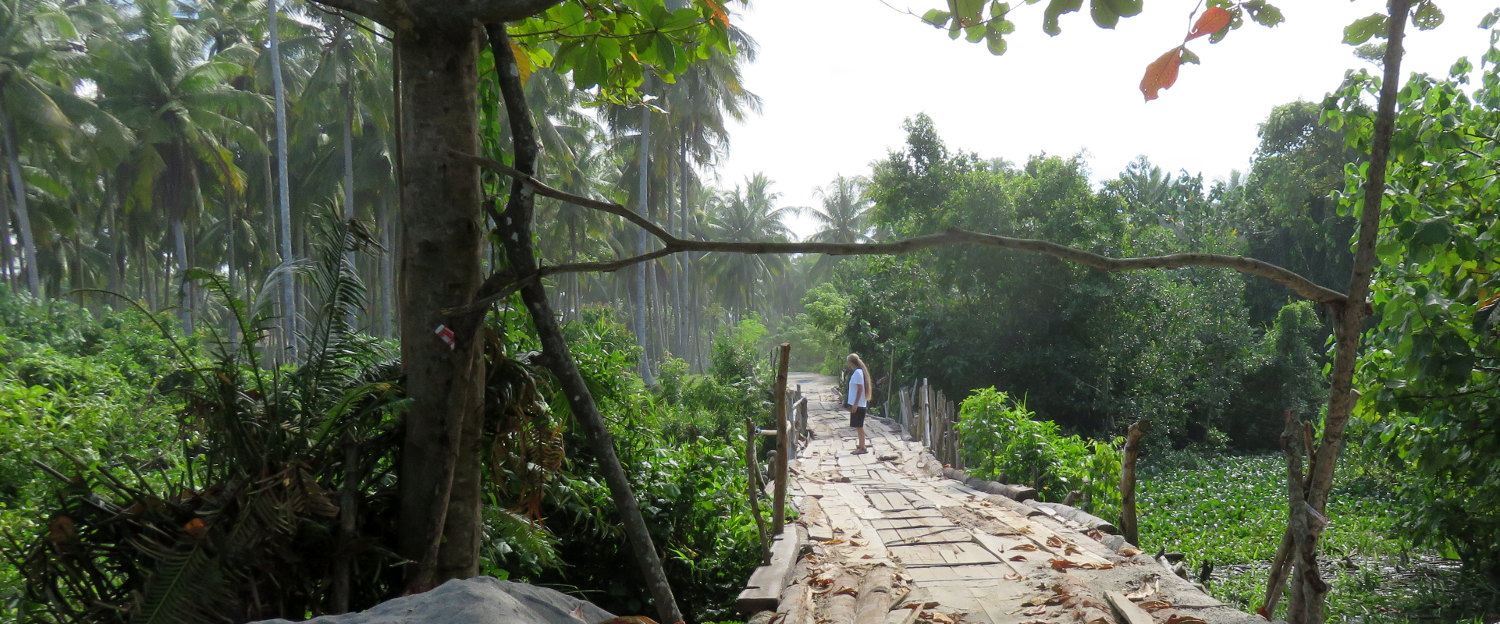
[1287,0,1412,624]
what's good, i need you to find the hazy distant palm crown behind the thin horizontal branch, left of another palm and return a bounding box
[705,173,794,320]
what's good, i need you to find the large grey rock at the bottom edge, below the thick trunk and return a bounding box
[255,576,614,624]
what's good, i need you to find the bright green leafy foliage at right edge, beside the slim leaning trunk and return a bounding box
[1328,29,1500,584]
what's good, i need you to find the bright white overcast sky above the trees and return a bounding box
[717,0,1500,236]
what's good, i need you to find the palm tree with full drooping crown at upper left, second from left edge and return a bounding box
[98,0,267,332]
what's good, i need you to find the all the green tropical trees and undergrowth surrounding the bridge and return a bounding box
[0,0,1500,621]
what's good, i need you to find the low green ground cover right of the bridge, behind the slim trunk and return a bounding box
[1137,453,1500,624]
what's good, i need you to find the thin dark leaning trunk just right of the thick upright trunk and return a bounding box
[489,27,683,623]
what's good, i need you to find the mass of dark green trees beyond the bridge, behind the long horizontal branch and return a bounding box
[834,116,1322,447]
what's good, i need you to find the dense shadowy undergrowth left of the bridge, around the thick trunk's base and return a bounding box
[0,288,768,621]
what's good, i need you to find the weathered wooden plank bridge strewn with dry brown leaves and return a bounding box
[740,374,1265,624]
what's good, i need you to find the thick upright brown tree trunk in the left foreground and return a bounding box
[396,19,485,591]
